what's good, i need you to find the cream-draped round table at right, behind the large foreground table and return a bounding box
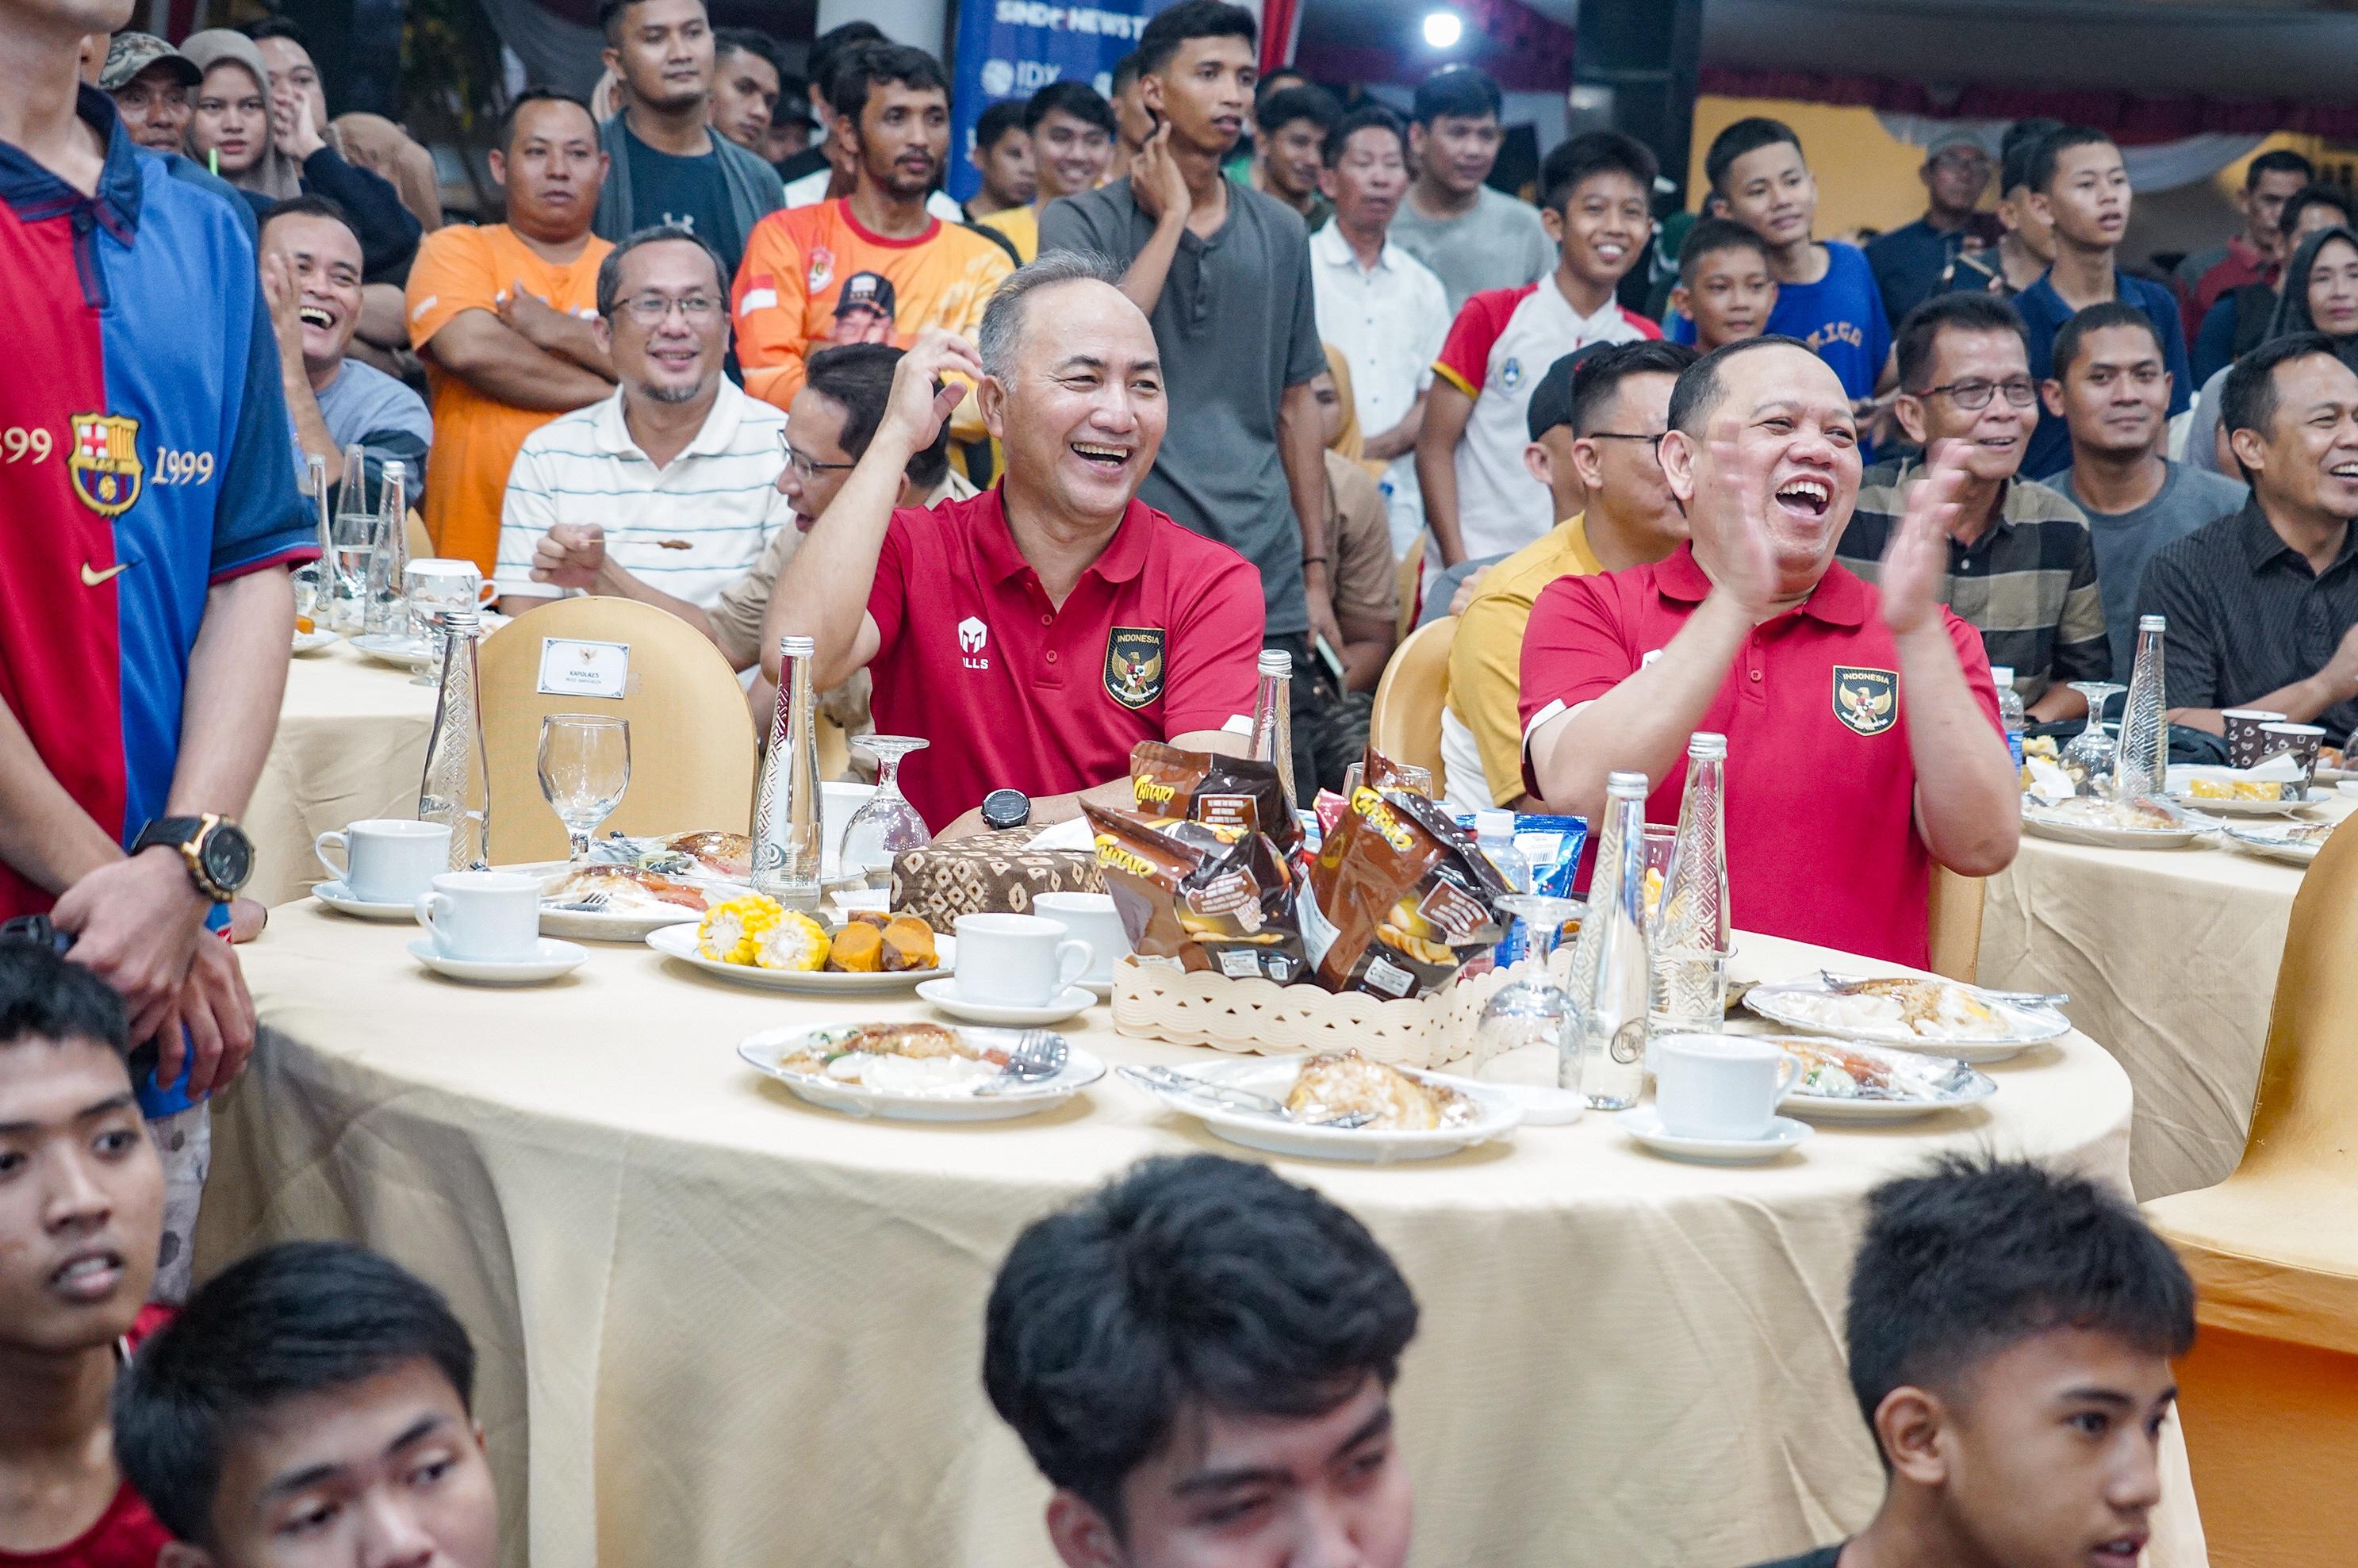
[1978,795,2358,1200]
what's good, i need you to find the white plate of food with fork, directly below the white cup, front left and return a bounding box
[738,1023,1106,1122]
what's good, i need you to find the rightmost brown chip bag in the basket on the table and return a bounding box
[1297,785,1514,998]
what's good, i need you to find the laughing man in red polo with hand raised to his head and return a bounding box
[766,252,1263,837]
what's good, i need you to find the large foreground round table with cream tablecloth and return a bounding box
[198,903,2205,1568]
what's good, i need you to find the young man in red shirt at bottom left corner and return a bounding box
[0,938,172,1568]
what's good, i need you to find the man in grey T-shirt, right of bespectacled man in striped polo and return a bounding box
[2042,300,2245,677]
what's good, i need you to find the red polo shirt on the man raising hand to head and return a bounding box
[868,485,1262,832]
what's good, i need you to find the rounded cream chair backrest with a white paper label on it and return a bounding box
[481,599,754,865]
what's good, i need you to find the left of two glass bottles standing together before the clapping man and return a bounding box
[1559,773,1653,1110]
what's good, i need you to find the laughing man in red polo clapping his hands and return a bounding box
[1524,337,2021,967]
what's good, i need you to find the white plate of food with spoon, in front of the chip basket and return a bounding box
[1122,1052,1524,1165]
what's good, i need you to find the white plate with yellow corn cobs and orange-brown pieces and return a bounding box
[646,894,957,995]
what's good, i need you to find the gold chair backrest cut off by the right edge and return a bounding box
[2235,827,2358,1181]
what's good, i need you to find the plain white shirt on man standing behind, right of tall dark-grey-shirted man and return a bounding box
[1311,219,1450,557]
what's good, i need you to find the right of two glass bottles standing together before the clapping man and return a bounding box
[1646,731,1728,1035]
